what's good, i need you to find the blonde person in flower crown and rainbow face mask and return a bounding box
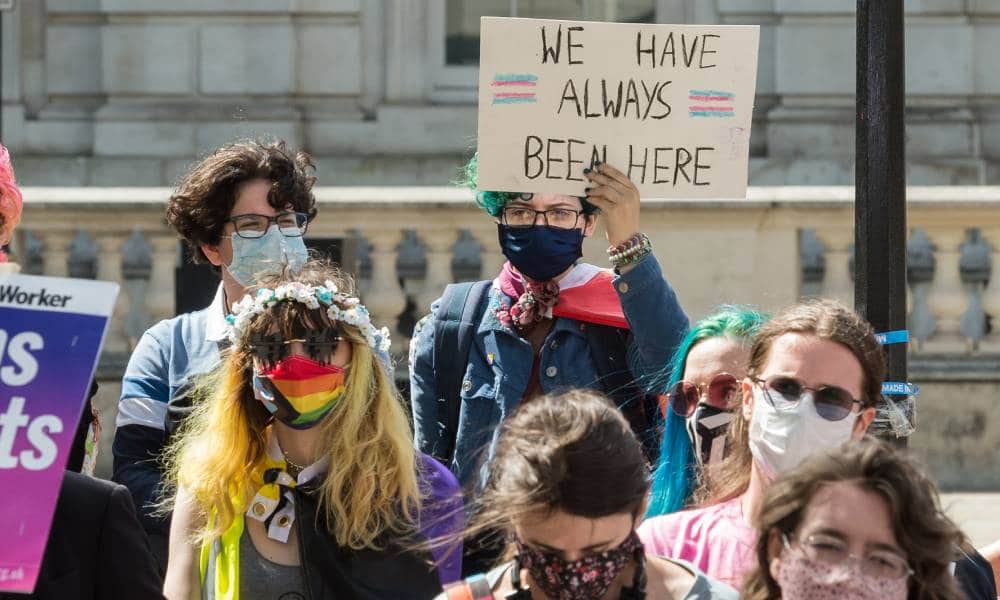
[164,261,463,600]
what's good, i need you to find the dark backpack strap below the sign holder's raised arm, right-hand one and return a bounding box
[585,323,660,464]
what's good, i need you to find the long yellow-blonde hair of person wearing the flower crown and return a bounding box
[167,261,421,550]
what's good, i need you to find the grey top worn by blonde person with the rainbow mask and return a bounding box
[202,529,306,600]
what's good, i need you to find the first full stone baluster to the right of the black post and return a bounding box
[925,227,966,353]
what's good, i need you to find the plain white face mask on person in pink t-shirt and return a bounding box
[750,384,858,480]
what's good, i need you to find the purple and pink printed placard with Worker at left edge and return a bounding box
[0,275,118,593]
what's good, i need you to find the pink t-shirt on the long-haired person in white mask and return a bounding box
[639,497,757,589]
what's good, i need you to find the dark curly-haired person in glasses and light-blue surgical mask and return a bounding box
[112,141,316,570]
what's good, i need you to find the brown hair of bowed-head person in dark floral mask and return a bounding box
[466,389,650,556]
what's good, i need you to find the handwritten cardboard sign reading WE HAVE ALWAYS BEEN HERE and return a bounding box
[478,17,760,198]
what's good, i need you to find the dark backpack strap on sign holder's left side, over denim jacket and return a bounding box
[431,280,493,465]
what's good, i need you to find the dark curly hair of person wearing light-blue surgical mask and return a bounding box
[167,140,316,263]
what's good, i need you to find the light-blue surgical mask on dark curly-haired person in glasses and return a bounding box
[226,225,309,287]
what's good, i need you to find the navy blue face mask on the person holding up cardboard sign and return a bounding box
[497,223,583,281]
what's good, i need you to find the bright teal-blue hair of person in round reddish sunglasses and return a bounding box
[646,305,769,518]
